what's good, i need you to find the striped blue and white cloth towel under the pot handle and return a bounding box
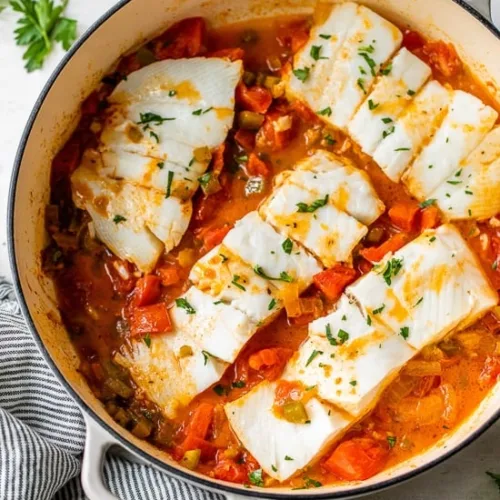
[0,282,223,500]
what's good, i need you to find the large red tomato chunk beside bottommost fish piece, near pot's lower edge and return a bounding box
[323,438,389,481]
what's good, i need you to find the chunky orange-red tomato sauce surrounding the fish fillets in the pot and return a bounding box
[43,10,500,488]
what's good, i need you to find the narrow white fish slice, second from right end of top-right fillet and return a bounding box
[403,90,498,200]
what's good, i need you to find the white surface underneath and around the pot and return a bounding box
[0,0,500,500]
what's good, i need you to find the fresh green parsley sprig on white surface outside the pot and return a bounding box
[10,0,76,72]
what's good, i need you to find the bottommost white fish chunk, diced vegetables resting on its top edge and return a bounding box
[224,381,351,481]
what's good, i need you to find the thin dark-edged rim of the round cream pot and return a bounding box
[7,0,500,500]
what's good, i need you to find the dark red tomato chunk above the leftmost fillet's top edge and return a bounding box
[154,17,206,60]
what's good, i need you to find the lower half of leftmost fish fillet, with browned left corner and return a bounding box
[71,167,192,272]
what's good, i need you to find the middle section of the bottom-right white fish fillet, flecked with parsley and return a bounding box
[283,296,416,417]
